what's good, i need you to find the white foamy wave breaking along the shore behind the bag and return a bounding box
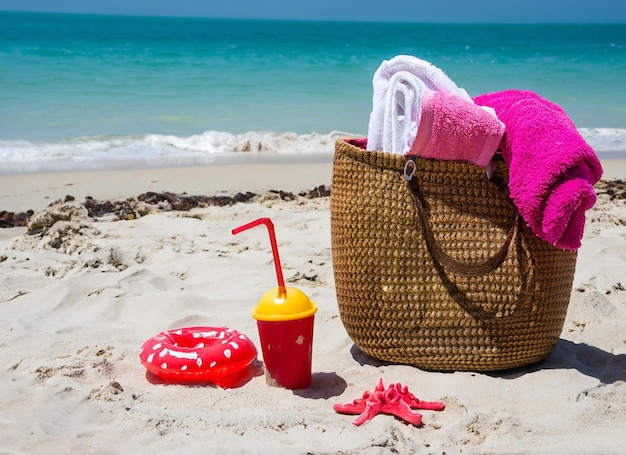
[0,128,626,174]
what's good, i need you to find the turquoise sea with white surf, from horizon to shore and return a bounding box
[0,11,626,173]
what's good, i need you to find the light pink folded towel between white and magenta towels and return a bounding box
[407,90,504,167]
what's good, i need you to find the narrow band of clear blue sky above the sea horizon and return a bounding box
[0,0,626,22]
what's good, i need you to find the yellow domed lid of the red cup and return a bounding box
[252,287,317,322]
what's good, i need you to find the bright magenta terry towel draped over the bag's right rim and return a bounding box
[474,90,602,250]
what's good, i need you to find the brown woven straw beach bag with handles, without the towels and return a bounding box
[331,140,576,371]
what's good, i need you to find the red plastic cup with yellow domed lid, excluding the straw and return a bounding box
[252,288,317,390]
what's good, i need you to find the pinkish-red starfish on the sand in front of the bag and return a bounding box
[333,378,445,426]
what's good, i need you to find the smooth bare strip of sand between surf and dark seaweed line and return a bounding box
[0,154,626,212]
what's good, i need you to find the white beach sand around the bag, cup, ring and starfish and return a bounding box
[0,159,626,454]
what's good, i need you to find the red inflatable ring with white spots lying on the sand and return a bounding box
[139,327,257,385]
